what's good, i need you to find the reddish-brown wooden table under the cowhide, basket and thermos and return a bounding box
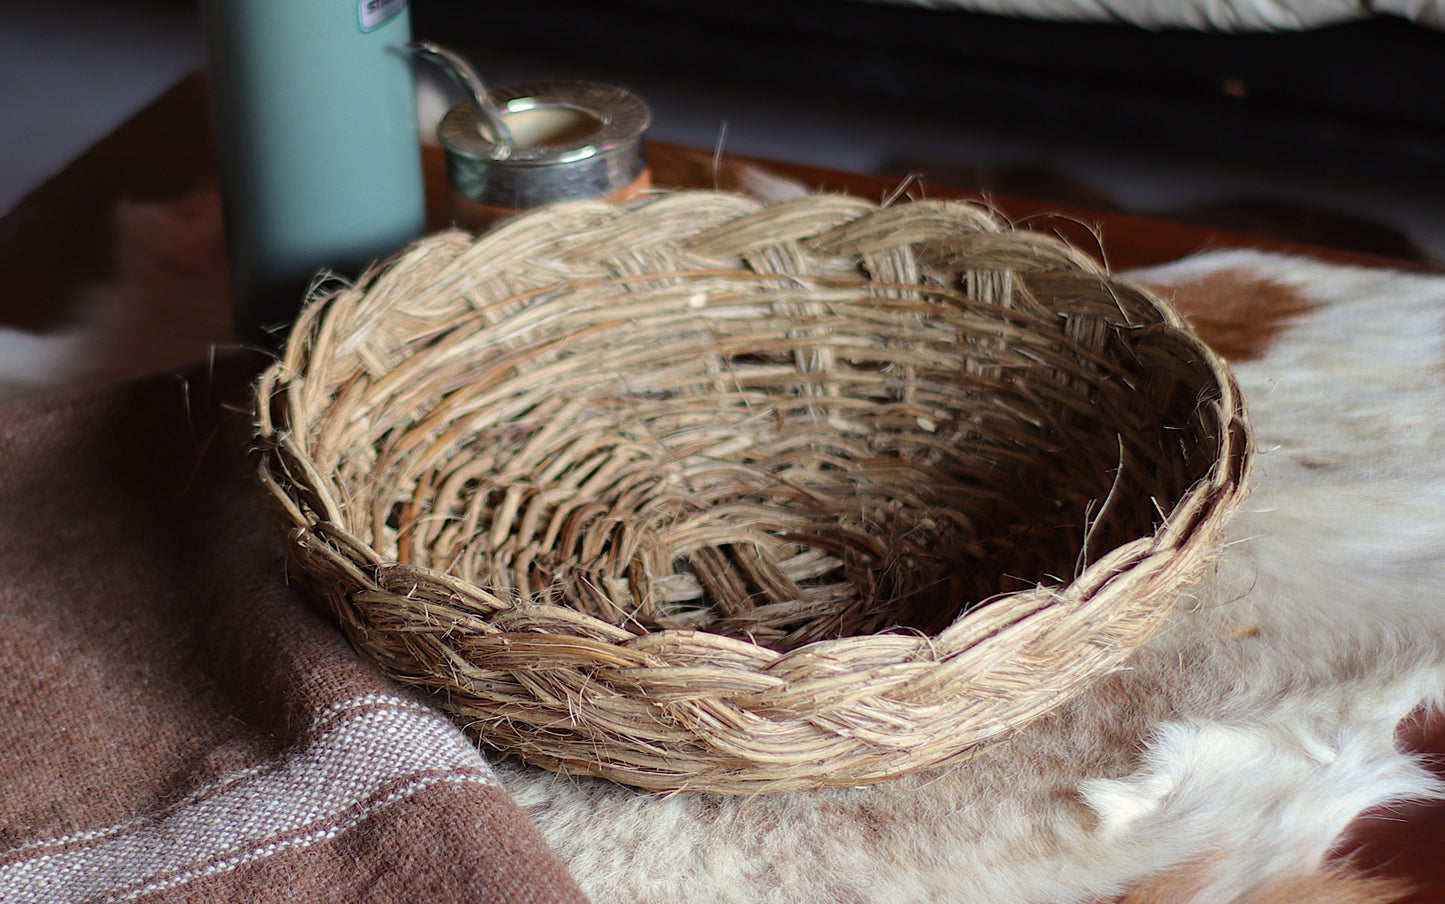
[0,75,1445,904]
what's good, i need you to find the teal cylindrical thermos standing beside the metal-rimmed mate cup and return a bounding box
[201,0,426,347]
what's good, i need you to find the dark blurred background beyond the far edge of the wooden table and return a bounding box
[0,0,1445,261]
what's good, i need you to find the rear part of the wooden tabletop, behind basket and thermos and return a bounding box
[0,74,1423,331]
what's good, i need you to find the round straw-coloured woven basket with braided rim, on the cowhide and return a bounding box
[257,192,1250,793]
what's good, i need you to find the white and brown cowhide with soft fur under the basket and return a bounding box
[0,186,1445,904]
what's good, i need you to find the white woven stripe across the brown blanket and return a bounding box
[0,695,496,904]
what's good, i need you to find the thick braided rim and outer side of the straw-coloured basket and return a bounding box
[254,191,1253,794]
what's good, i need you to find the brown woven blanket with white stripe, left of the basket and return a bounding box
[0,357,582,904]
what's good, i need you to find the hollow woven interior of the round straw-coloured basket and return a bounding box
[311,222,1220,650]
